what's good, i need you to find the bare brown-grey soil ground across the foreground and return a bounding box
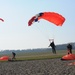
[0,59,75,75]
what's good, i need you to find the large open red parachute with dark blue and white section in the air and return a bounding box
[28,12,65,26]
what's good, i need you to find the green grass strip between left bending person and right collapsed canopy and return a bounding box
[16,50,75,60]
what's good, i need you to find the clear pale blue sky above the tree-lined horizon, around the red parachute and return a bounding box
[0,0,75,50]
